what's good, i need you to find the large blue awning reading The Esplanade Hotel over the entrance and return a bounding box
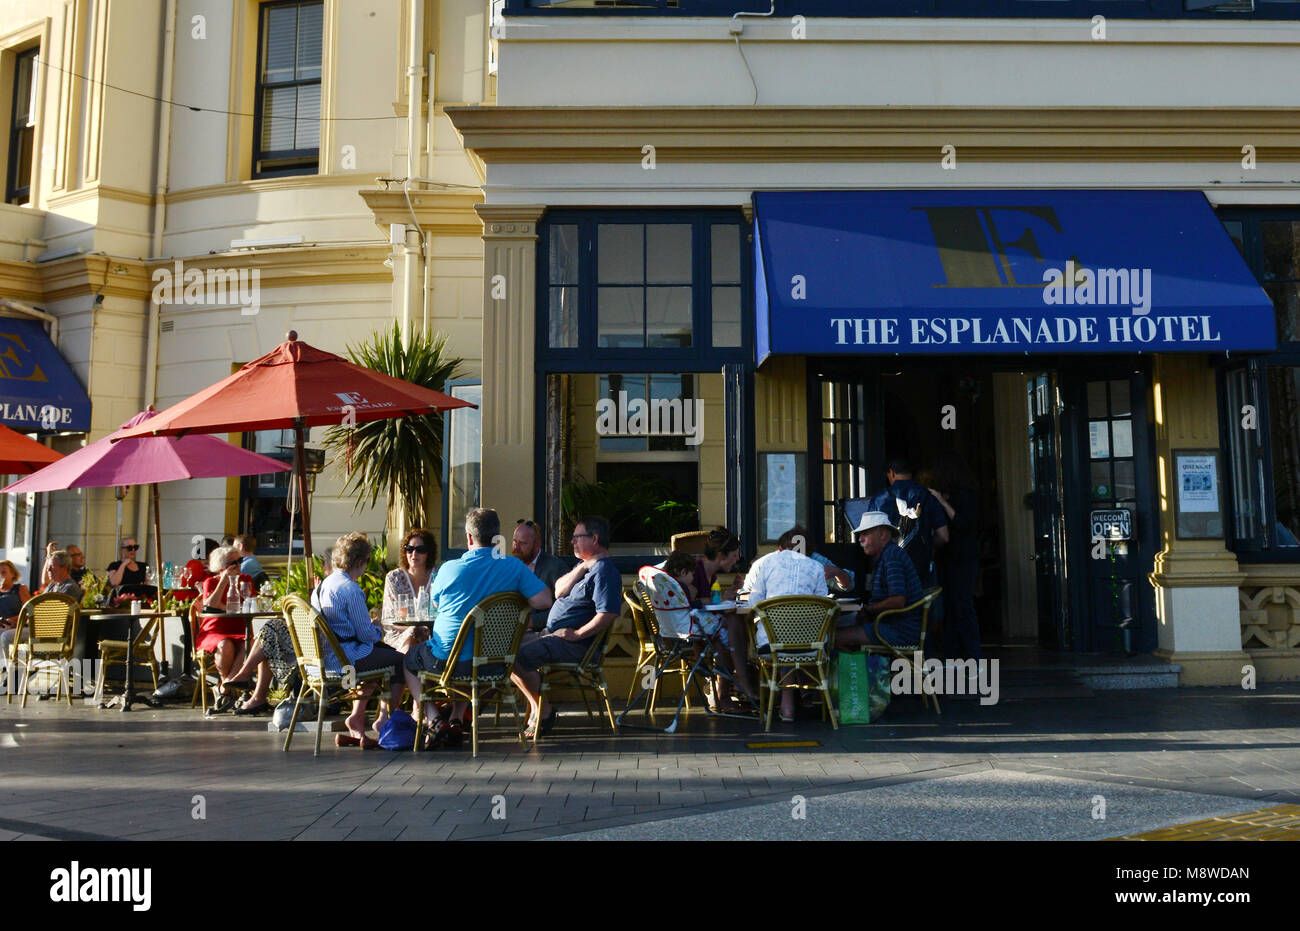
[754,190,1277,363]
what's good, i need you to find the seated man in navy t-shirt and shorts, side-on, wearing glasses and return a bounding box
[511,516,623,736]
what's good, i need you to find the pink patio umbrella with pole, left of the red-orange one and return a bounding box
[3,406,290,711]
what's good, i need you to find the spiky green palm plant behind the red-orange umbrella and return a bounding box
[325,321,464,527]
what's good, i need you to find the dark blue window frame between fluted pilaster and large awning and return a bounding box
[533,208,755,572]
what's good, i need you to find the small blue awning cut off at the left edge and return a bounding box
[0,317,90,433]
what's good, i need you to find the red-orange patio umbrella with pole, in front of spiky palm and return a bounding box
[117,330,473,572]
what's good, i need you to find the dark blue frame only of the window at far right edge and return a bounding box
[1216,207,1300,563]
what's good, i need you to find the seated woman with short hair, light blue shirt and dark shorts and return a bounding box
[312,533,406,750]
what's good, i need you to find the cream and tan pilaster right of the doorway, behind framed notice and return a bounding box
[1151,354,1251,685]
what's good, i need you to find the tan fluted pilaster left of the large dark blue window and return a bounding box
[475,204,546,533]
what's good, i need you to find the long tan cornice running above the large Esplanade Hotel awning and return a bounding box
[446,107,1300,164]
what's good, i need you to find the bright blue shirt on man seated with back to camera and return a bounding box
[429,546,546,662]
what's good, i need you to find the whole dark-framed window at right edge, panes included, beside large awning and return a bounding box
[1219,211,1300,562]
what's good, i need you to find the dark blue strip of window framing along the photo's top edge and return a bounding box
[504,0,1300,21]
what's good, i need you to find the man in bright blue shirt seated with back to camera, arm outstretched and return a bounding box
[406,507,551,746]
